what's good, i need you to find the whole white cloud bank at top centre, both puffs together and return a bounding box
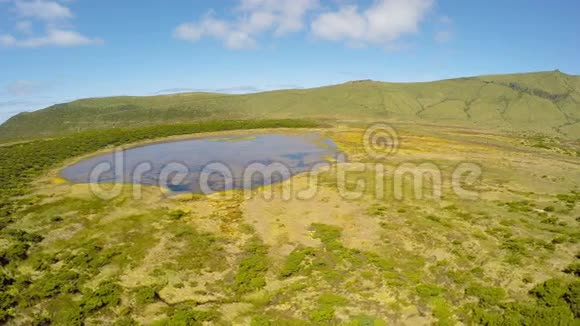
[173,0,436,49]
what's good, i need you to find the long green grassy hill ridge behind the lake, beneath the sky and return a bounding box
[0,71,580,140]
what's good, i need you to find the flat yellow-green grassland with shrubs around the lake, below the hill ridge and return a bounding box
[0,121,580,325]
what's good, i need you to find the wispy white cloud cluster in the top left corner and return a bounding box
[0,0,103,48]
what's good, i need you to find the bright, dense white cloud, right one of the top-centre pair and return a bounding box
[311,0,434,46]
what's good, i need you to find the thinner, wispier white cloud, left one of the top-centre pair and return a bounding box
[173,0,318,49]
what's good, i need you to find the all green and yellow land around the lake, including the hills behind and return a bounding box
[0,72,580,326]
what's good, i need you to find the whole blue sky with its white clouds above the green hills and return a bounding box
[0,0,580,122]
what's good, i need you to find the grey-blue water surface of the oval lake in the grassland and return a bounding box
[61,133,336,192]
